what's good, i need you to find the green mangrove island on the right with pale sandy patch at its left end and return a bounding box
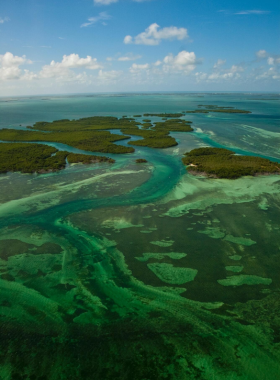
[182,148,280,179]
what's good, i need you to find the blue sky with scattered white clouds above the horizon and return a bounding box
[0,0,280,96]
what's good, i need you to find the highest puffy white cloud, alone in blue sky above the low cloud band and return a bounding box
[124,23,188,45]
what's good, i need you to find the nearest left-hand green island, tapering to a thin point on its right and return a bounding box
[0,143,114,173]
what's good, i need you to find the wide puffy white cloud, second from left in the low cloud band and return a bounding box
[40,54,102,78]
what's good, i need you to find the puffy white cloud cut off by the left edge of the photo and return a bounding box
[0,52,32,80]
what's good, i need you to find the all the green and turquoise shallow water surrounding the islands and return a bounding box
[0,94,280,380]
